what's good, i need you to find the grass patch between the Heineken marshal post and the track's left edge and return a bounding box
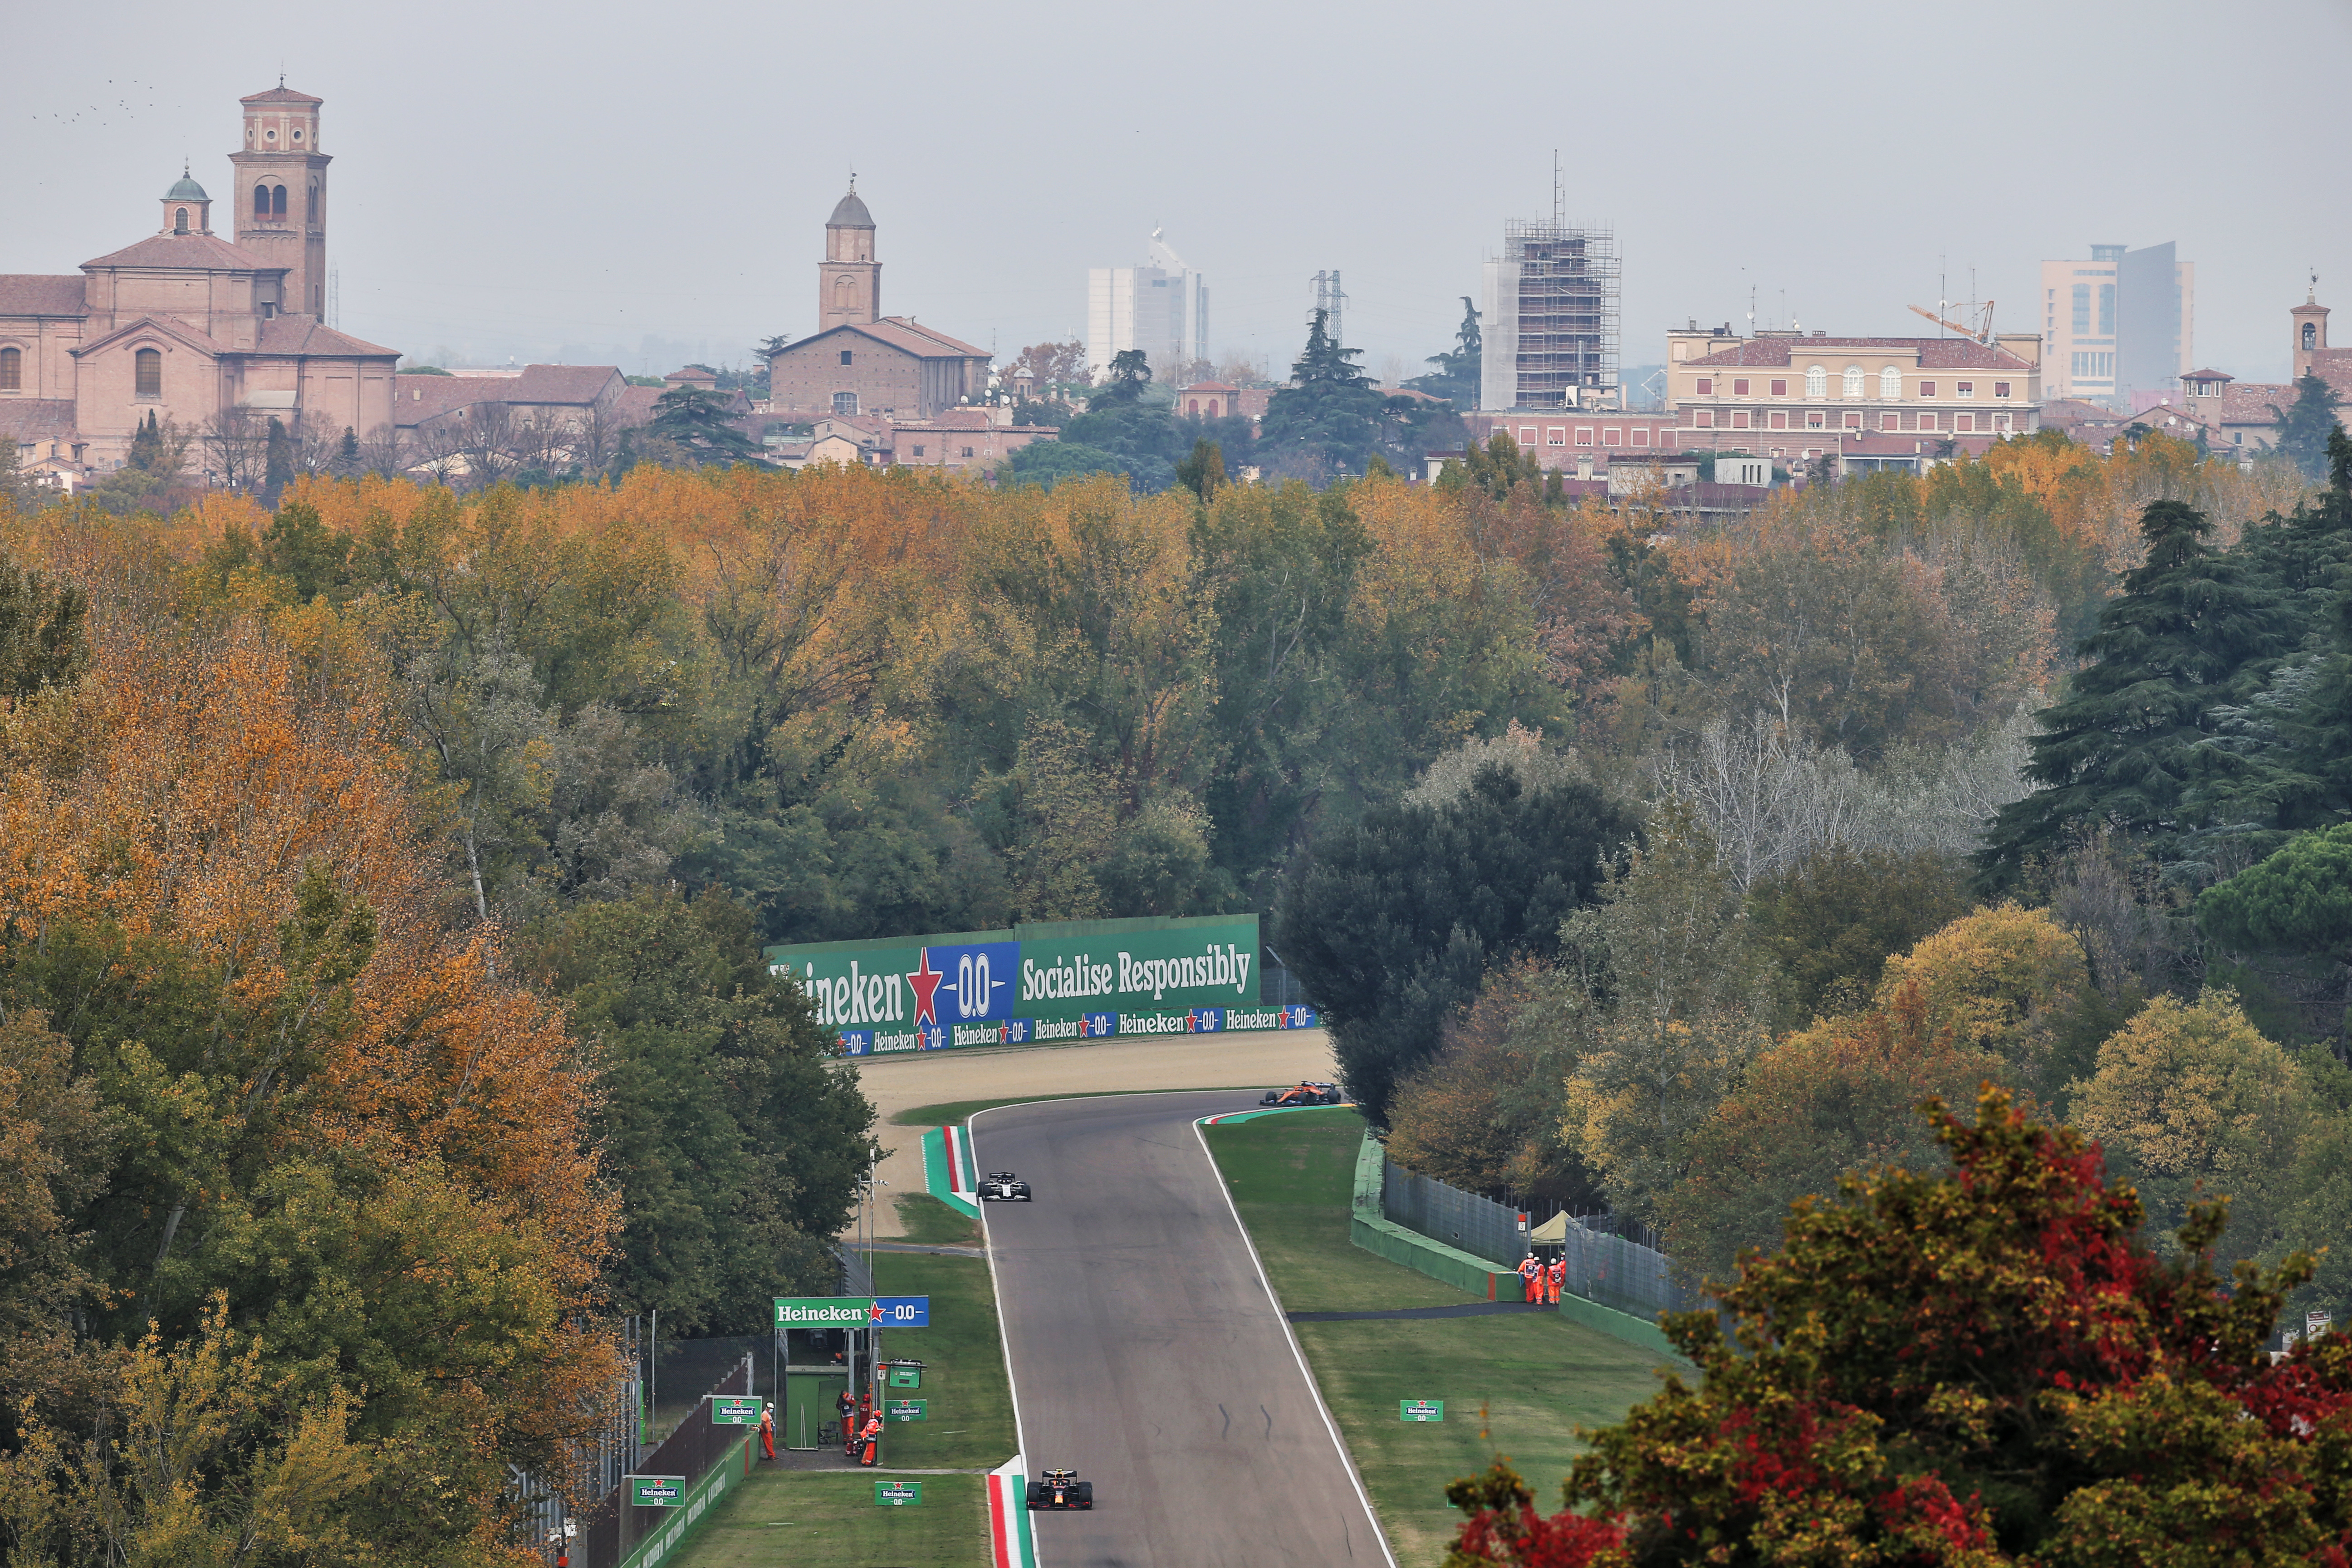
[875,1253,1014,1469]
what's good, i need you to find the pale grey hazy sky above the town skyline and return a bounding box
[0,0,2352,378]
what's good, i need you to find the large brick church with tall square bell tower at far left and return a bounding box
[0,82,400,482]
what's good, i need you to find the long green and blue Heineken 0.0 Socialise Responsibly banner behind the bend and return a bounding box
[767,915,1317,1055]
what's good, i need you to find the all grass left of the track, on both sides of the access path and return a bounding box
[677,1250,1014,1568]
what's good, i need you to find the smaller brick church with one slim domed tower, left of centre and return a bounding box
[767,179,990,421]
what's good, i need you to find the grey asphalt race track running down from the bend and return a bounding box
[971,1088,1392,1568]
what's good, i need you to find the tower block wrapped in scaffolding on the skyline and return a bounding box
[1480,219,1625,412]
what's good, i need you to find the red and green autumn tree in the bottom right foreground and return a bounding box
[1446,1088,2352,1568]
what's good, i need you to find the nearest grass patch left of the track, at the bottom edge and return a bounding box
[677,1467,988,1568]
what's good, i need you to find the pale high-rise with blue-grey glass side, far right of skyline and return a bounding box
[2042,240,2197,414]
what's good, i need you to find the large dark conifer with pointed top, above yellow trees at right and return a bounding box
[1978,501,2293,889]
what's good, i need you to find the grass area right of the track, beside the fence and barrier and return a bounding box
[1206,1110,1663,1568]
